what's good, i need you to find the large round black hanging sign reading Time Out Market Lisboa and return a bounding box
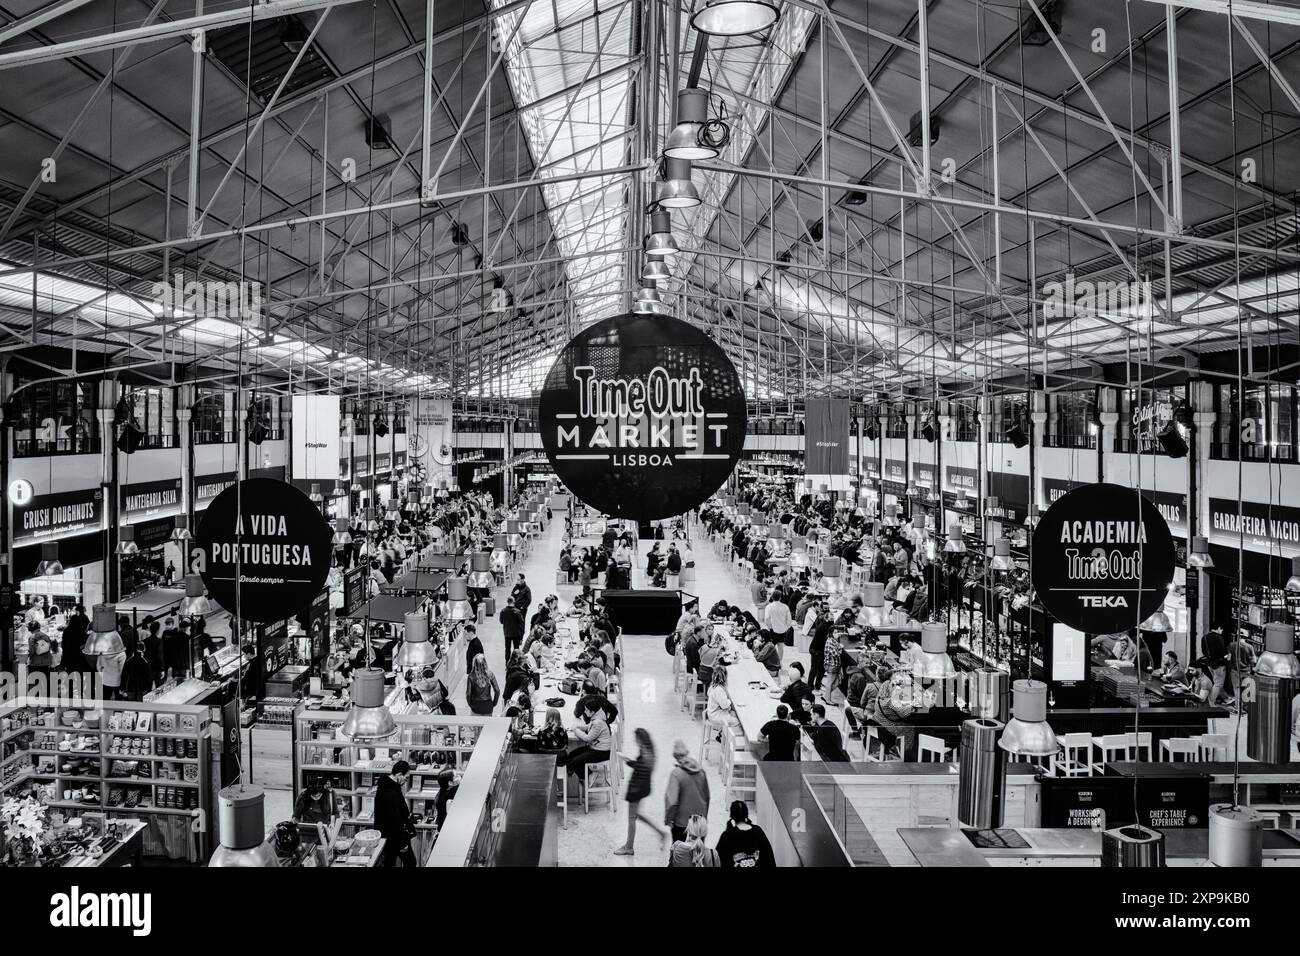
[538,315,745,520]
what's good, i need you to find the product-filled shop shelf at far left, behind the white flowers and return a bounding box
[0,698,212,861]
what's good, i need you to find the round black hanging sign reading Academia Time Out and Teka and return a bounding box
[1032,484,1174,633]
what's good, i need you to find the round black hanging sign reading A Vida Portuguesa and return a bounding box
[190,479,332,623]
